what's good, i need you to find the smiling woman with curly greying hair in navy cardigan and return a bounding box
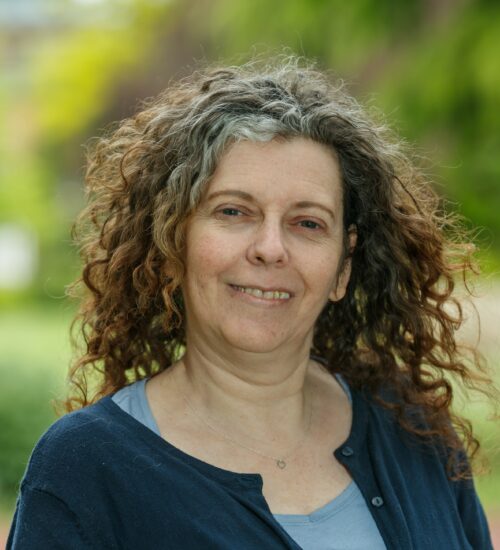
[8,59,492,550]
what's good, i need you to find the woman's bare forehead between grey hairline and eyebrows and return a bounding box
[206,138,342,203]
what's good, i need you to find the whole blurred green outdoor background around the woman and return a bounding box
[0,0,500,543]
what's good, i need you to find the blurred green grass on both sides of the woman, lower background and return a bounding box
[0,302,500,524]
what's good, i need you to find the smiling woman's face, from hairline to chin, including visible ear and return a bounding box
[182,138,353,352]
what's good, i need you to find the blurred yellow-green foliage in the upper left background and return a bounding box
[0,1,178,304]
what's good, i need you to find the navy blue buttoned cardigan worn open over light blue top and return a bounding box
[7,391,493,550]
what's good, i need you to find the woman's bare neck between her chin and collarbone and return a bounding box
[177,339,312,447]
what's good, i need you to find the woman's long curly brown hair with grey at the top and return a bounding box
[63,57,493,475]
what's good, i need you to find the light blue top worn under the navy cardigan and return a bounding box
[112,375,386,550]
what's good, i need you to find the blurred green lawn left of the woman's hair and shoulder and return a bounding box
[0,304,72,509]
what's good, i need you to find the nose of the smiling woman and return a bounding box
[247,219,288,265]
